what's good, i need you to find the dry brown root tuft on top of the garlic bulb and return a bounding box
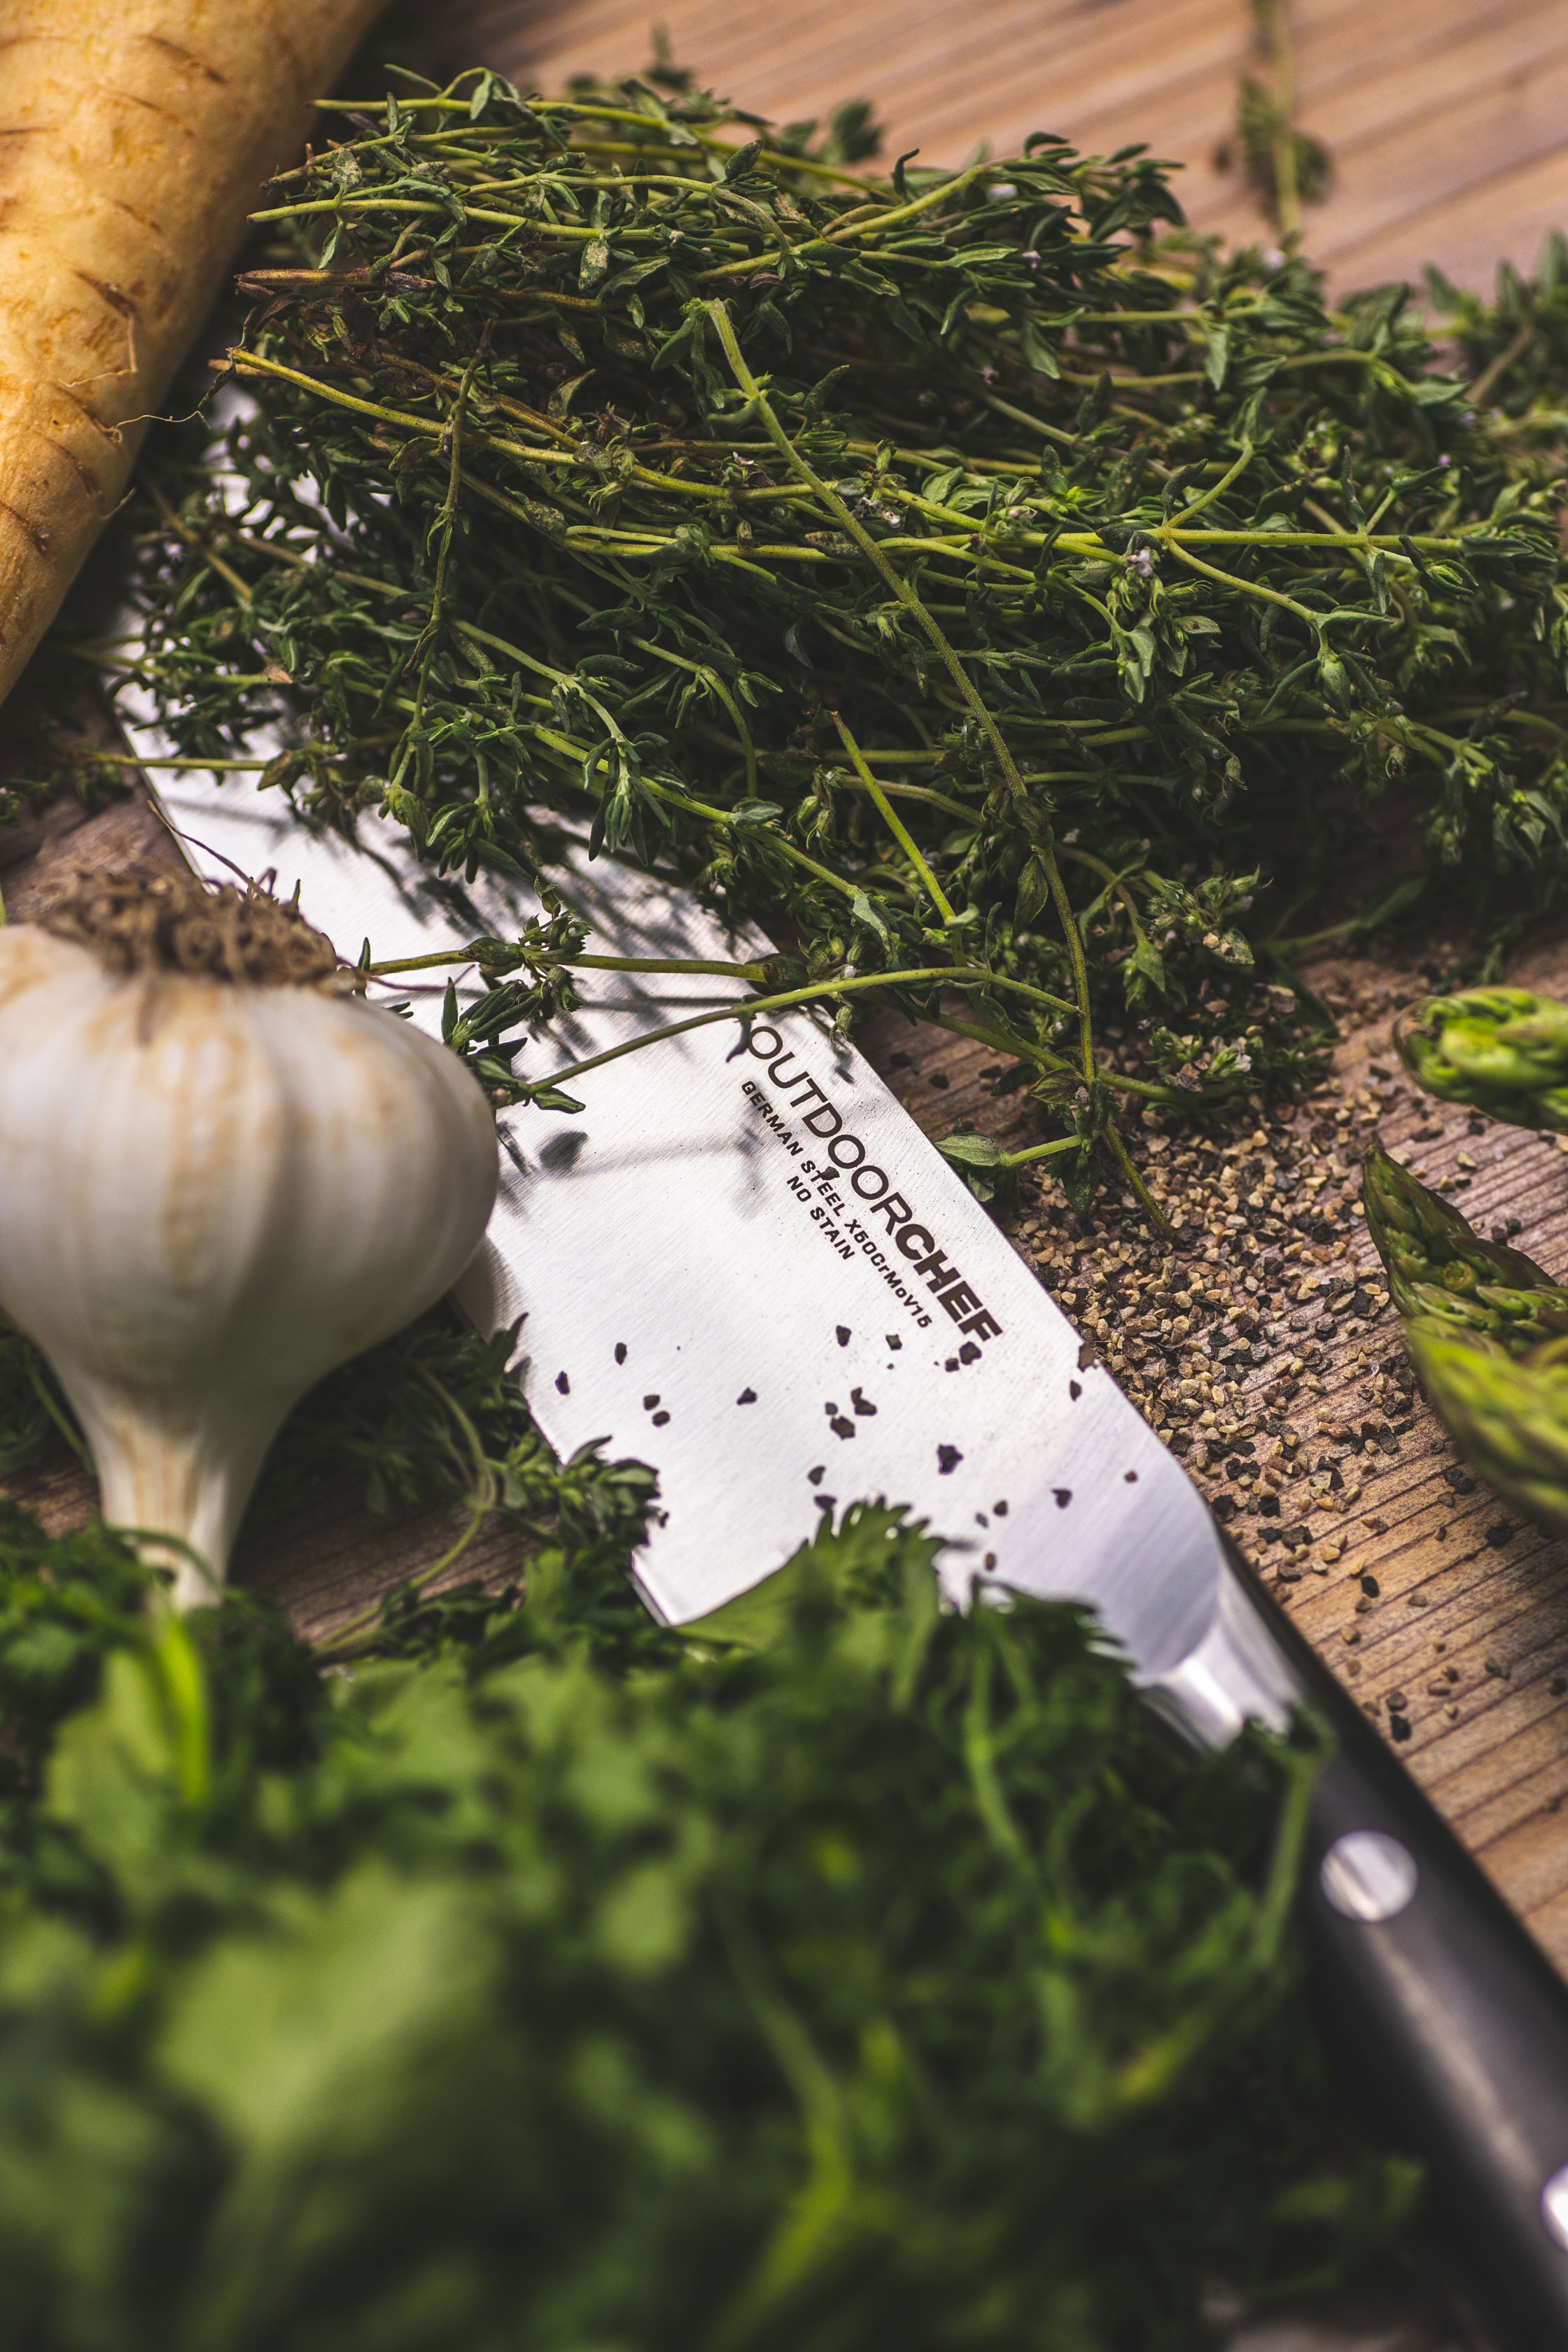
[38,868,348,995]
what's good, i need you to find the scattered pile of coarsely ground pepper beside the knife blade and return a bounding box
[1016,974,1415,1583]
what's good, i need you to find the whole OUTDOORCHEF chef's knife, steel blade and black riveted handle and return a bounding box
[153,776,1568,2347]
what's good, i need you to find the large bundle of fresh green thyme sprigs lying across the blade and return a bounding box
[88,71,1568,1200]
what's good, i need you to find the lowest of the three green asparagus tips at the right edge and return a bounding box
[1406,1315,1568,1529]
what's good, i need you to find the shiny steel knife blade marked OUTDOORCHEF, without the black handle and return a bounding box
[150,774,1295,1743]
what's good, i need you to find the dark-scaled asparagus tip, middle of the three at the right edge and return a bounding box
[1361,1147,1568,1354]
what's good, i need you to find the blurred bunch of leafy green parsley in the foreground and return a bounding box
[0,1508,1413,2352]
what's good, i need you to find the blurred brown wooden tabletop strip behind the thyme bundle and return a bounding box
[442,0,1568,289]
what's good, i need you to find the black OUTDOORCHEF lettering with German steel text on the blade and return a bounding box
[741,1028,1002,1369]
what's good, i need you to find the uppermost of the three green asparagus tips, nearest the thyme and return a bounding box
[1394,988,1568,1131]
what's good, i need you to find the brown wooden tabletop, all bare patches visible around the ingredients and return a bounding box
[0,0,1568,2352]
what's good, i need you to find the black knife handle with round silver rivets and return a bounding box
[1244,1571,1568,2352]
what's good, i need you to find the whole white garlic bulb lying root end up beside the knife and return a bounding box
[0,877,496,1606]
